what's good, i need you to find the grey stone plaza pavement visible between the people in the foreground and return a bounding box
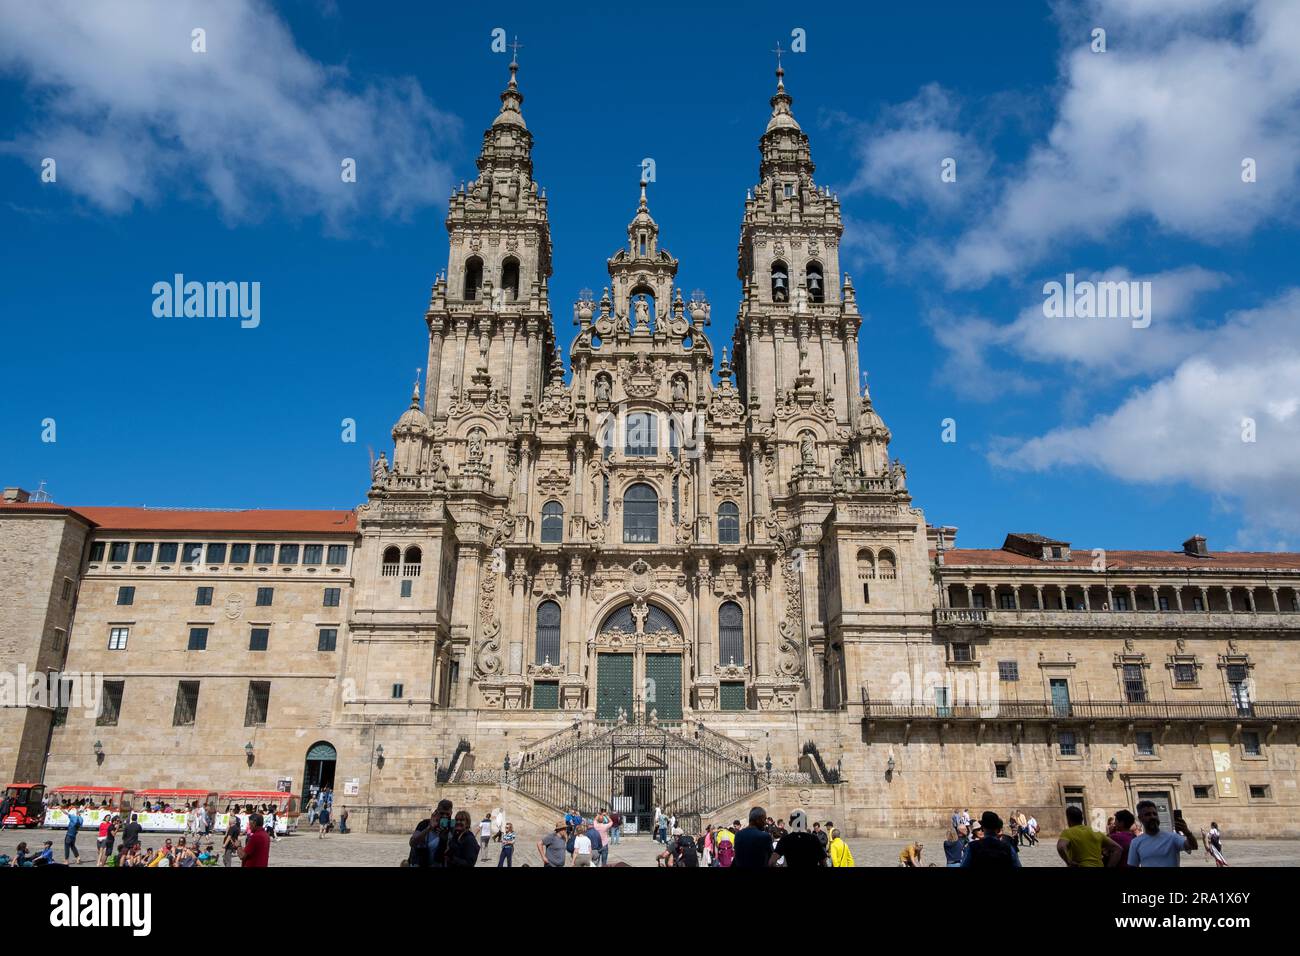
[0,829,1300,866]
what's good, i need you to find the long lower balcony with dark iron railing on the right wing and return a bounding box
[862,697,1300,723]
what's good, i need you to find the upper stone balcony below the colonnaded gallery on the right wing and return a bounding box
[935,607,1300,631]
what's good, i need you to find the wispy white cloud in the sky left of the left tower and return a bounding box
[0,0,458,226]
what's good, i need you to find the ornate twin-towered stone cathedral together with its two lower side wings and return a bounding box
[0,64,1300,835]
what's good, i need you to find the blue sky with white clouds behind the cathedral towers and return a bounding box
[0,0,1300,549]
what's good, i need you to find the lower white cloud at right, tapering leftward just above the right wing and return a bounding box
[991,289,1300,541]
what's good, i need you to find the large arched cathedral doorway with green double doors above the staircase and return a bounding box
[595,601,685,723]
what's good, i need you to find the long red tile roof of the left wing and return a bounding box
[0,502,356,535]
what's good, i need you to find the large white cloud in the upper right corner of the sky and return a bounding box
[939,0,1300,286]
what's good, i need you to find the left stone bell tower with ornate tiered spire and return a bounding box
[425,52,555,420]
